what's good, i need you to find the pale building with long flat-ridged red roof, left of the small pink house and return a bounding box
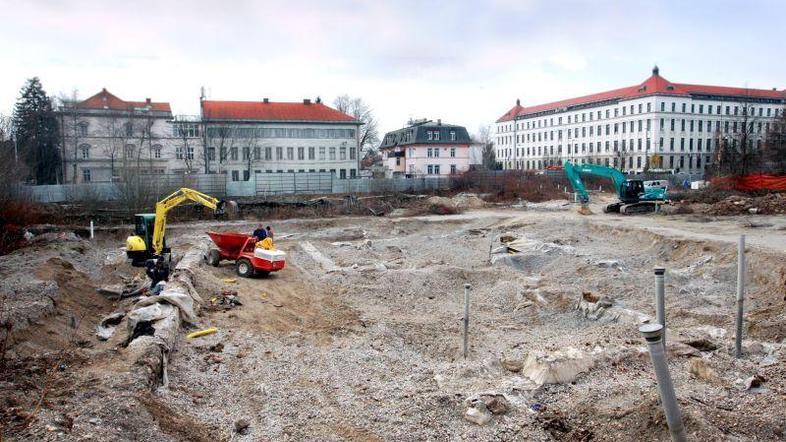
[201,98,362,181]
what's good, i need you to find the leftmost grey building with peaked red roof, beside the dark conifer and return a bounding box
[58,89,178,183]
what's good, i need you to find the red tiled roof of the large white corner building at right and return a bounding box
[497,70,786,123]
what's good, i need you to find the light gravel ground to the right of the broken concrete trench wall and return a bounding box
[3,208,786,441]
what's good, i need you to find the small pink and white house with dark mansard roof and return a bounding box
[379,120,471,177]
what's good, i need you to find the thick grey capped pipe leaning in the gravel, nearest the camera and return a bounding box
[639,324,687,442]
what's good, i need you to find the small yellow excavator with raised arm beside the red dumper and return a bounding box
[126,187,236,266]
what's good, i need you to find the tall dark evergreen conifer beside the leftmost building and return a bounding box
[14,77,61,184]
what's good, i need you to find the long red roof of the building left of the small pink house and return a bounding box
[202,100,357,122]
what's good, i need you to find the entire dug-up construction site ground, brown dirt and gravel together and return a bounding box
[0,179,786,441]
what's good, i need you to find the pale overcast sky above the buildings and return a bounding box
[0,0,786,136]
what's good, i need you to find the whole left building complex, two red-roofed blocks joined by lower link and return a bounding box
[58,89,361,183]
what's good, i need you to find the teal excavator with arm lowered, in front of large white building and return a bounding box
[564,161,666,214]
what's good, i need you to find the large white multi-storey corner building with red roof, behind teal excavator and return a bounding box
[495,66,786,173]
